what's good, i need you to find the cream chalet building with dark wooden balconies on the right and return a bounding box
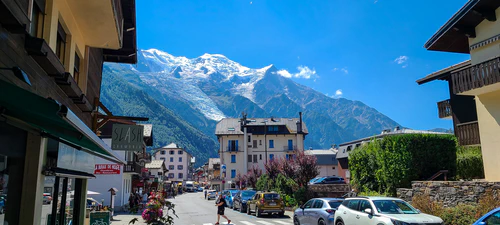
[417,0,500,181]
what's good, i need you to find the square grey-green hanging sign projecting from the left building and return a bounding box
[111,124,144,151]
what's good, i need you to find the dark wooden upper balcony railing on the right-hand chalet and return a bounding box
[451,58,500,94]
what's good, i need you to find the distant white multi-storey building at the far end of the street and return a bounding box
[154,143,193,182]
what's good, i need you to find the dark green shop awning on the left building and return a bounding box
[0,80,125,164]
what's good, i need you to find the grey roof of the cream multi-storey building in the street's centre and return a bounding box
[215,118,308,135]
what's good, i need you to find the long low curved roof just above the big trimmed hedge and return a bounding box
[337,128,453,159]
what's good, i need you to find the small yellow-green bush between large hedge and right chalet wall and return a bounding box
[456,147,484,180]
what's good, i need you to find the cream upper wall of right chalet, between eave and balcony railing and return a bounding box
[469,8,500,64]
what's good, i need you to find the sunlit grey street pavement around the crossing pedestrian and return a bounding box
[112,193,293,225]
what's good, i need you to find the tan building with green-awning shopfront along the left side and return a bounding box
[0,0,137,225]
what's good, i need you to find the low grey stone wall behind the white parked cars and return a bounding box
[397,181,500,207]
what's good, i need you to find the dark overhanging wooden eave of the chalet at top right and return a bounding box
[424,0,500,53]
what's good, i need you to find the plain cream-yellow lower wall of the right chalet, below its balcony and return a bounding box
[476,90,500,181]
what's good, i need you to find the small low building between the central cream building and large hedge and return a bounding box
[304,148,339,177]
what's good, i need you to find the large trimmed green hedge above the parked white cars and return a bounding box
[349,134,457,195]
